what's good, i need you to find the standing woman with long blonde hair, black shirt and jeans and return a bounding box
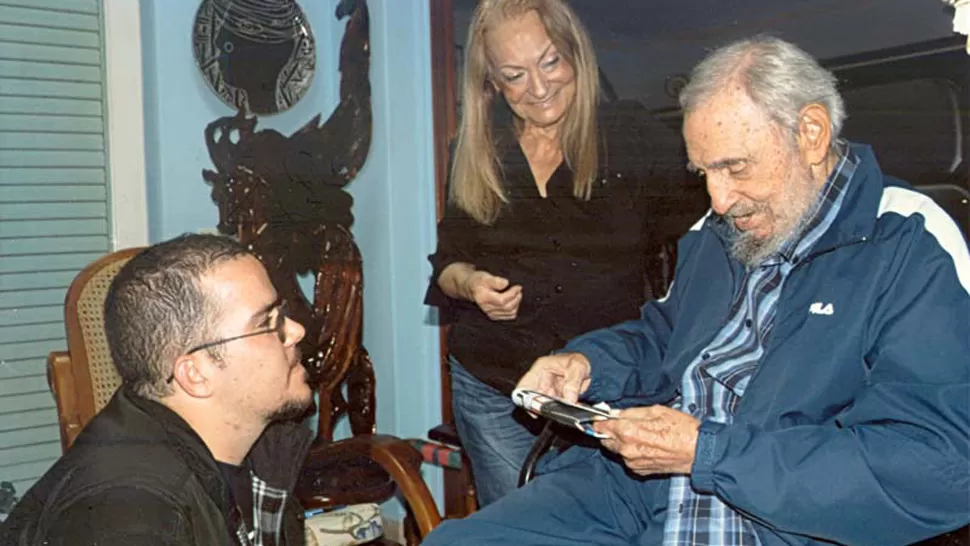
[427,0,684,505]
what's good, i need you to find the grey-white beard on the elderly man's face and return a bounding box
[724,166,820,268]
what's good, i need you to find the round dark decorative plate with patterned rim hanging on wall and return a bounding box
[192,0,316,114]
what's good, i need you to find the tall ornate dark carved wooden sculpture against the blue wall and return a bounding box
[202,0,370,438]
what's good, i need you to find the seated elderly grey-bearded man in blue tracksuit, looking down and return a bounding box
[426,38,970,546]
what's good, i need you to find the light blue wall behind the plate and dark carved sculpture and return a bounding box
[141,0,441,504]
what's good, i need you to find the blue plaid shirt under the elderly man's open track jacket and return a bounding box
[663,142,859,546]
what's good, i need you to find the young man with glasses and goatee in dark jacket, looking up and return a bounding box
[0,235,311,546]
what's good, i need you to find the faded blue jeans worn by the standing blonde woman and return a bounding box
[449,357,536,507]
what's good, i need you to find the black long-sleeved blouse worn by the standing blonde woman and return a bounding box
[425,100,706,393]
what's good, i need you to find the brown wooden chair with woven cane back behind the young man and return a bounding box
[47,248,441,544]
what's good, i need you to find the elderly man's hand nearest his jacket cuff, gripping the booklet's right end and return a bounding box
[593,406,700,476]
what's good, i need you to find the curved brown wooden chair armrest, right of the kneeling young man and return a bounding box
[362,434,441,538]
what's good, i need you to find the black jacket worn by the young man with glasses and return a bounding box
[0,389,311,546]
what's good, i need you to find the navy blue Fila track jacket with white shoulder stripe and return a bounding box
[564,145,970,546]
